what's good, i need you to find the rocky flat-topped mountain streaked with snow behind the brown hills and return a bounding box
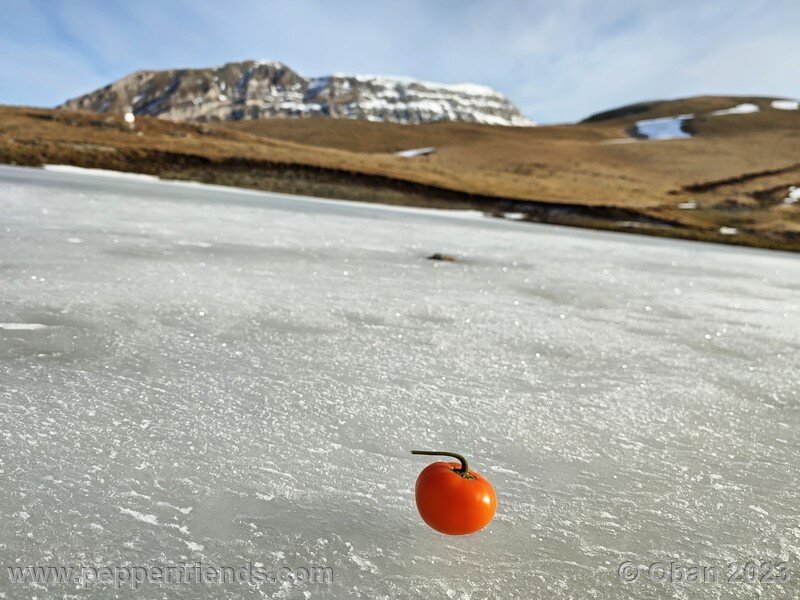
[62,61,535,126]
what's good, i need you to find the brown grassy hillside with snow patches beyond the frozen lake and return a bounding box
[0,97,800,249]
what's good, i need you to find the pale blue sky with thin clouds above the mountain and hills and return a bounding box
[0,0,800,122]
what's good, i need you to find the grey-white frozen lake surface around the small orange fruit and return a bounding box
[0,167,800,600]
